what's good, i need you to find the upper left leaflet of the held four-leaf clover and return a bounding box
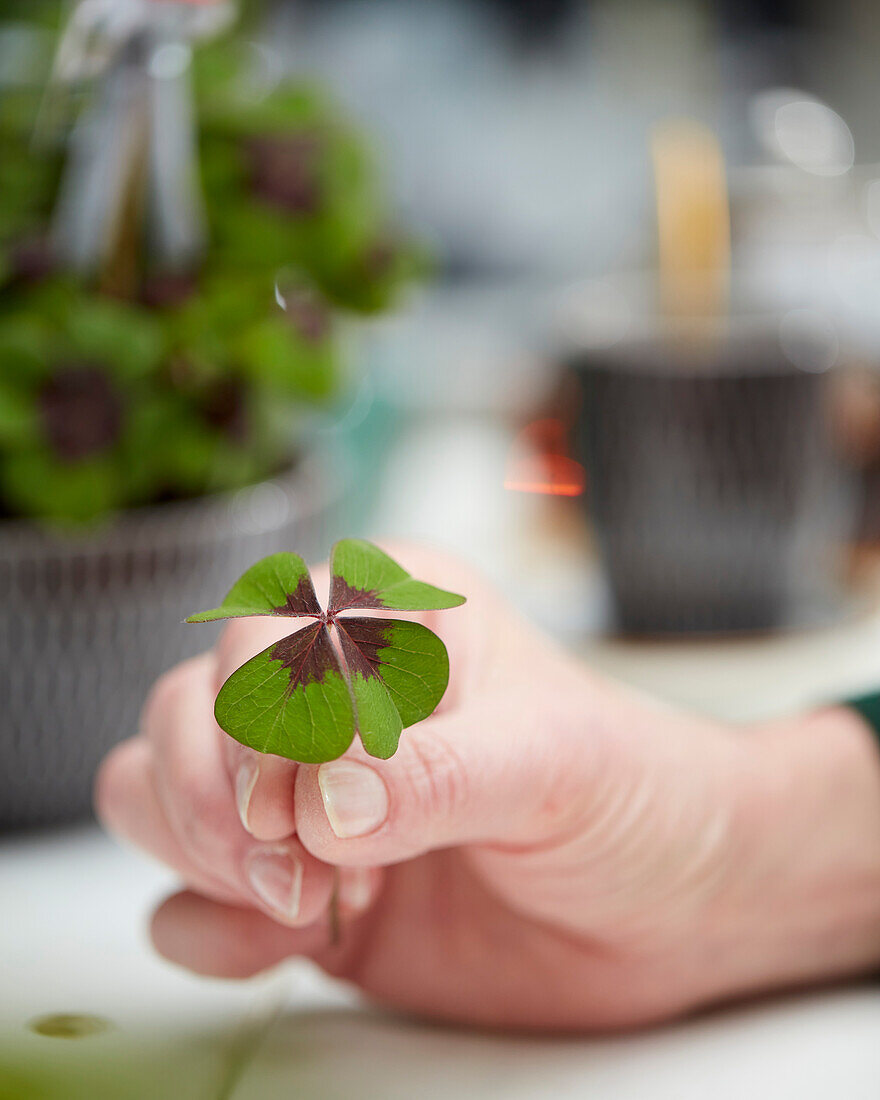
[186,553,321,623]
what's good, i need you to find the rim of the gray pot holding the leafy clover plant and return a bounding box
[0,451,334,562]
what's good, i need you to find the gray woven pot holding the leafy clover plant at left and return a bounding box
[0,451,339,831]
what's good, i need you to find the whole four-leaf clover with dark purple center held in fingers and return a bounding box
[187,539,464,763]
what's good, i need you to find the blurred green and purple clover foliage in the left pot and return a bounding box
[0,0,422,524]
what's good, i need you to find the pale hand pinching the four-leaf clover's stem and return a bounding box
[97,547,880,1029]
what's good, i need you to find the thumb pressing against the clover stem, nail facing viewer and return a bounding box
[295,684,594,866]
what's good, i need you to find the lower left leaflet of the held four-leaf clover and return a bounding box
[215,623,354,763]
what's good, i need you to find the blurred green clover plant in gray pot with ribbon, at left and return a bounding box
[0,0,417,827]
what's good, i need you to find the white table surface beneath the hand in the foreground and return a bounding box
[0,828,880,1100]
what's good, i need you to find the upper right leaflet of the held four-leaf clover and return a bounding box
[329,539,464,614]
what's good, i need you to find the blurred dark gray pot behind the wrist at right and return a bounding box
[573,329,851,635]
